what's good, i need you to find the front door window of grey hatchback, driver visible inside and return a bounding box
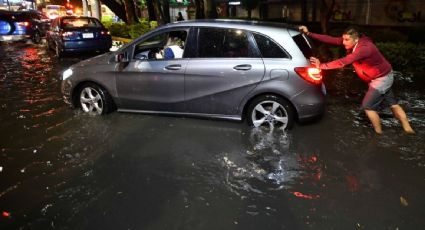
[133,30,187,60]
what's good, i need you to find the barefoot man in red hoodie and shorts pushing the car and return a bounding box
[299,26,415,134]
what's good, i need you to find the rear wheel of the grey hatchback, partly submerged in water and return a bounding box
[246,95,295,130]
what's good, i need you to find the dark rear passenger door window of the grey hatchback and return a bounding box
[198,28,258,58]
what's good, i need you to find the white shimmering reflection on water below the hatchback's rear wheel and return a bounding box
[219,128,301,197]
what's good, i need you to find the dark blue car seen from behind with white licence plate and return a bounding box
[46,16,112,57]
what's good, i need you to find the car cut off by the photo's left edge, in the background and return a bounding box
[0,10,50,44]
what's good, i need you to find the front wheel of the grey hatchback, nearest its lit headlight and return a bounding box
[77,83,115,115]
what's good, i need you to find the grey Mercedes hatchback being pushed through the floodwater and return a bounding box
[62,20,325,129]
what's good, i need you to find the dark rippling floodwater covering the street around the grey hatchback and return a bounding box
[0,43,425,230]
